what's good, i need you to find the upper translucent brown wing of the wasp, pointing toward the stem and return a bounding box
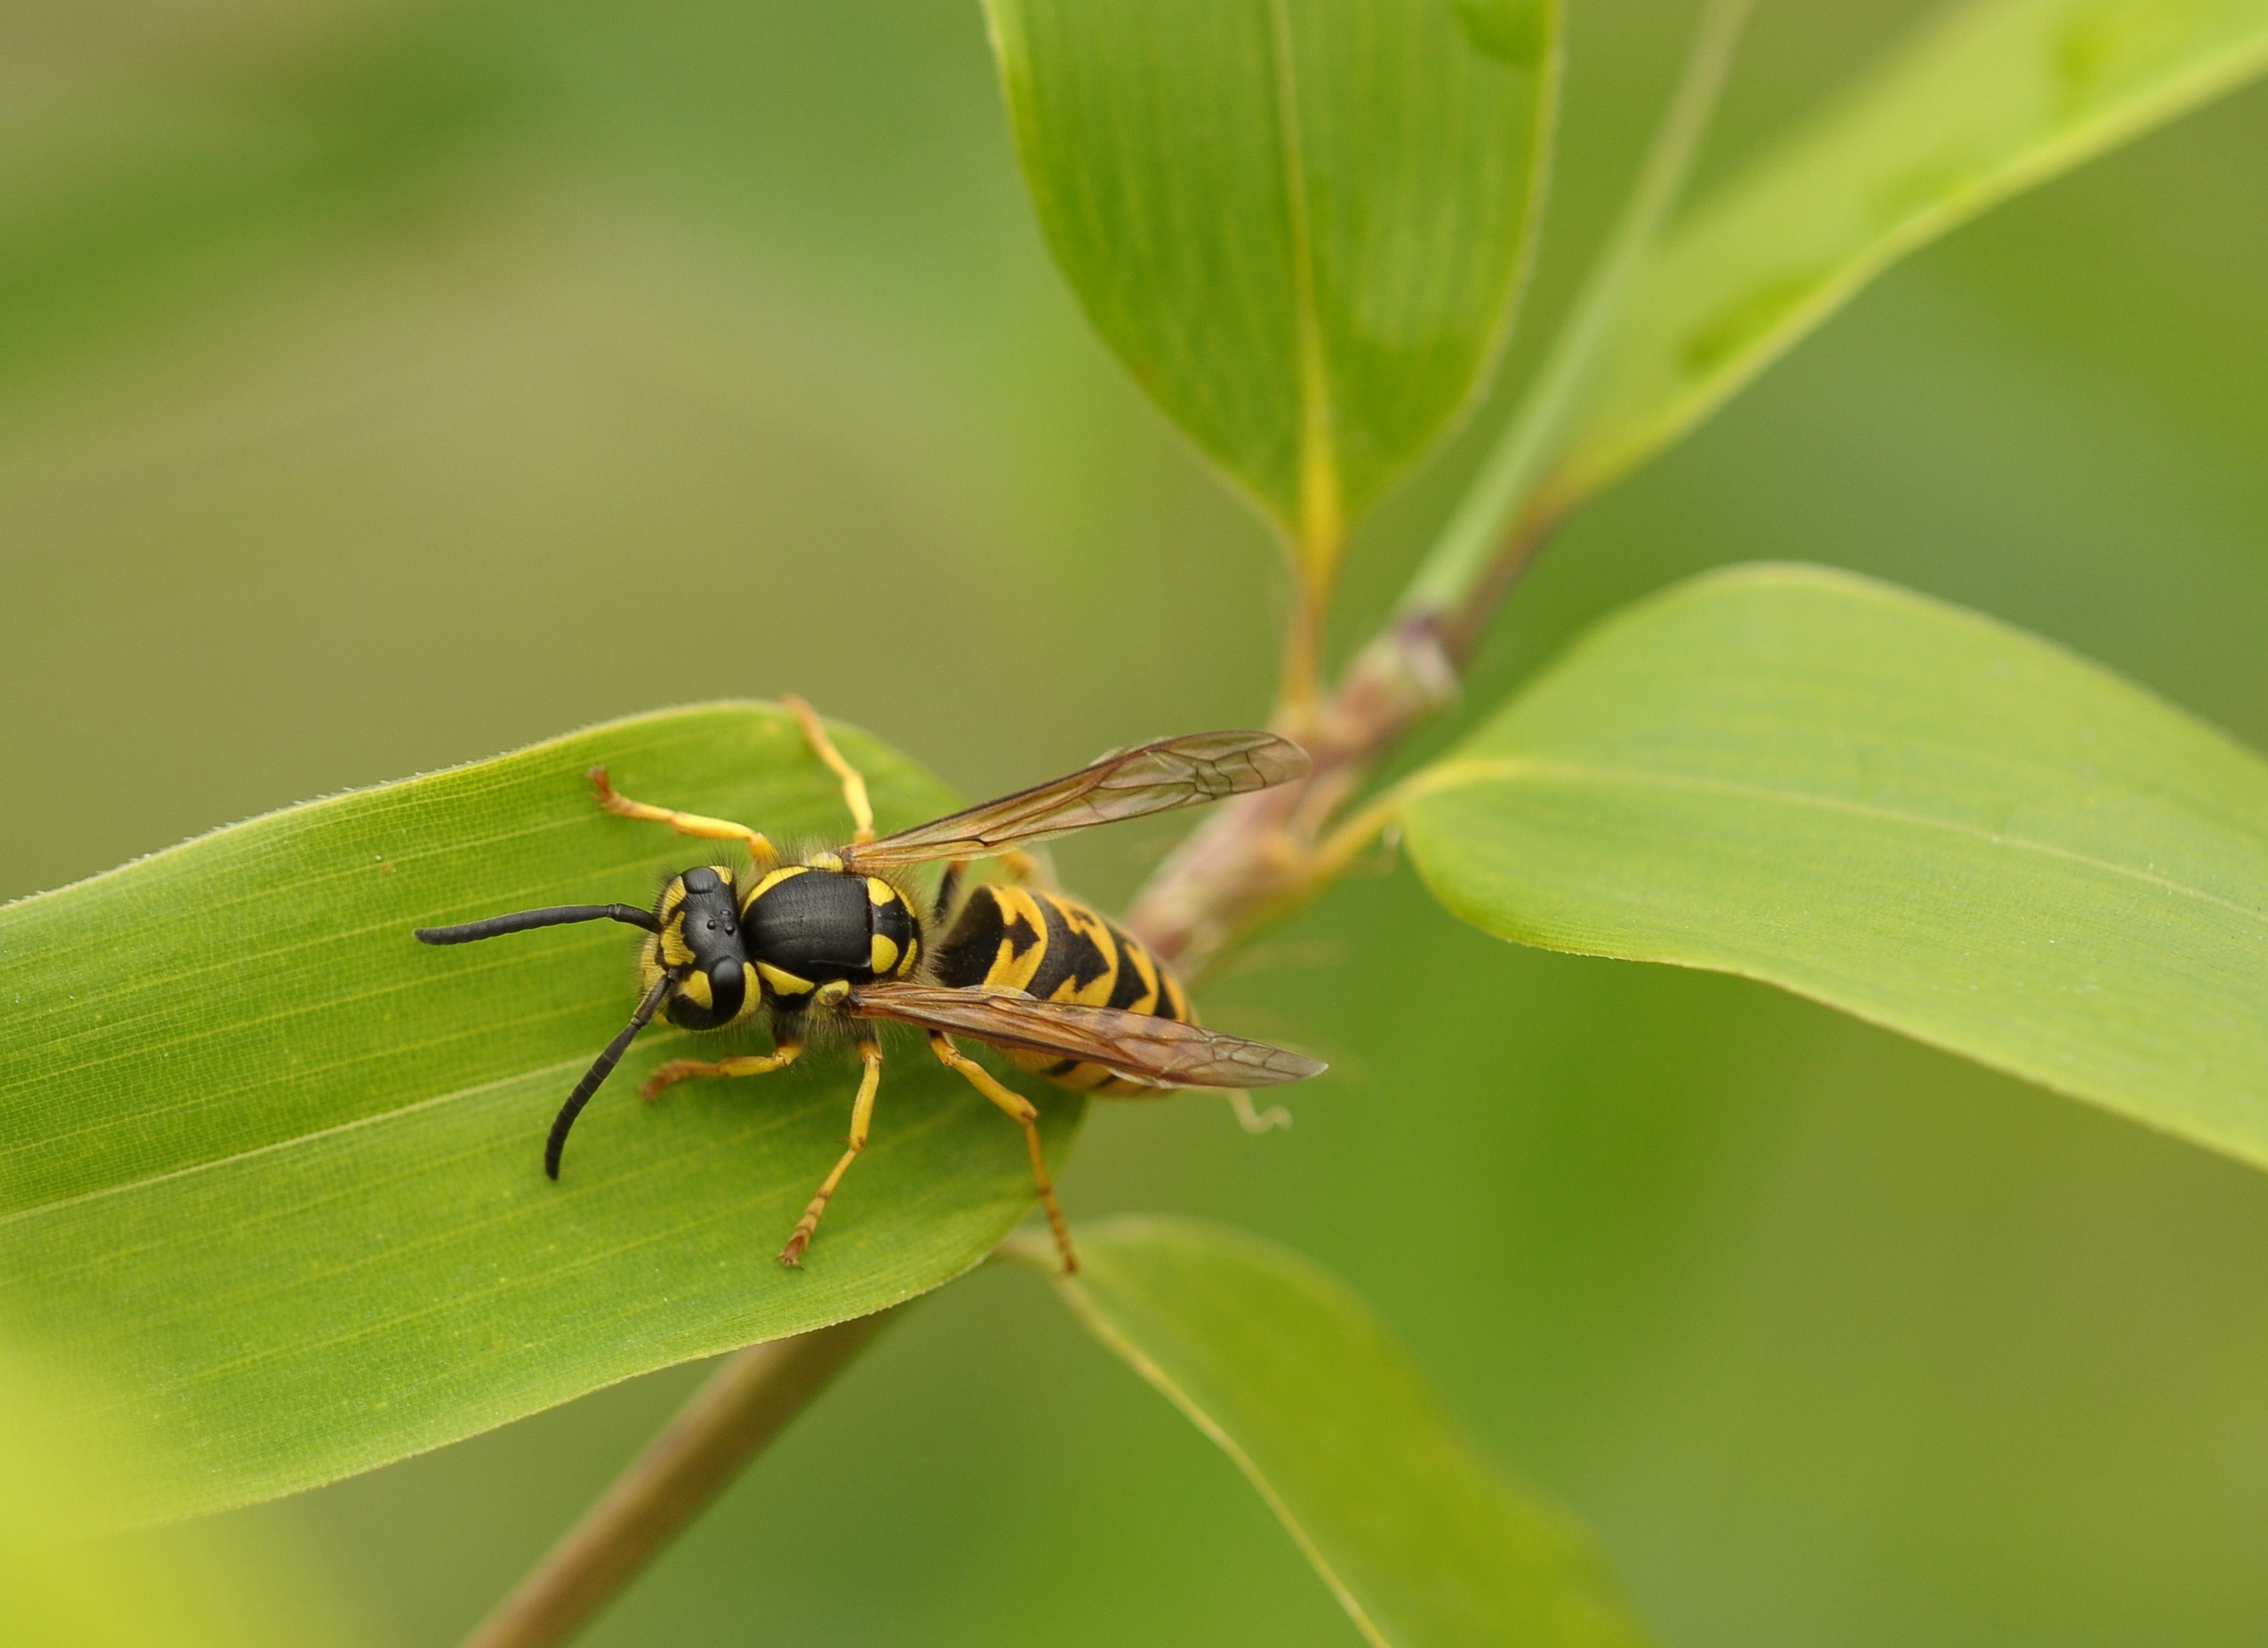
[841,732,1306,871]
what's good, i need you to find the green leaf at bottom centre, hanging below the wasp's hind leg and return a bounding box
[1009,1220,1647,1648]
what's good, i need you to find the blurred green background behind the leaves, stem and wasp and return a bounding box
[13,0,2268,1648]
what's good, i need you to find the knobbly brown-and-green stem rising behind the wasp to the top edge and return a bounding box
[1127,0,1751,977]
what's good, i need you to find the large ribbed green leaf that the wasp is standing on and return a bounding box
[0,705,1077,1517]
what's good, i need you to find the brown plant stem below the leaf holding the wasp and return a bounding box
[465,1310,896,1648]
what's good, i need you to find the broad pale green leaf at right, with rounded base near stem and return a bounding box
[1404,566,2268,1165]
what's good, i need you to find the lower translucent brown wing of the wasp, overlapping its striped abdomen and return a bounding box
[850,984,1324,1088]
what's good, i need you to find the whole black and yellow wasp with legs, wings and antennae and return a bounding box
[417,699,1324,1272]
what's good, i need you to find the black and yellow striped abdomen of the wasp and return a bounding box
[935,882,1197,1095]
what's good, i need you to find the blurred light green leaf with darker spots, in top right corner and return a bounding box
[1542,0,2268,508]
